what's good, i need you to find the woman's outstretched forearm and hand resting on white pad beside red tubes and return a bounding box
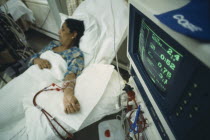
[63,73,80,114]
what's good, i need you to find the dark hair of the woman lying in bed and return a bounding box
[65,18,85,47]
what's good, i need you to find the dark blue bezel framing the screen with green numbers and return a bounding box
[128,5,199,114]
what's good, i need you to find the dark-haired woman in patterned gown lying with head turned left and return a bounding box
[29,19,84,113]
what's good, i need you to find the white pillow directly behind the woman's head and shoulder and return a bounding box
[60,13,100,67]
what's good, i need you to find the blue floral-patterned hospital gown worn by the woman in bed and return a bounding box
[29,41,84,77]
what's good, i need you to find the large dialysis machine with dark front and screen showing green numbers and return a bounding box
[127,0,210,140]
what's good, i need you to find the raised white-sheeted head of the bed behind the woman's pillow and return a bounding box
[73,0,129,64]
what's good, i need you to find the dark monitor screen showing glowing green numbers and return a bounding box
[138,19,183,92]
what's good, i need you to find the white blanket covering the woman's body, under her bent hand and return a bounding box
[0,51,67,139]
